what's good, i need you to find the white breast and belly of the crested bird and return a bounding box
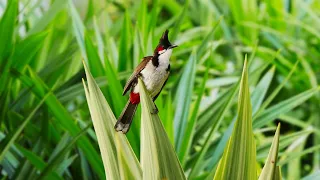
[134,49,172,97]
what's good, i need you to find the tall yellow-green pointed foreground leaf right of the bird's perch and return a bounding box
[214,57,257,180]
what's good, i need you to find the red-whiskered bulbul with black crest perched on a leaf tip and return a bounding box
[114,30,177,134]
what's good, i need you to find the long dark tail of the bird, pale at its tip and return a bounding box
[114,100,138,134]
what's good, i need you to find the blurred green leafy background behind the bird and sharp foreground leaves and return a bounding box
[0,0,320,180]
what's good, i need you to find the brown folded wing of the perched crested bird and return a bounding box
[122,56,153,95]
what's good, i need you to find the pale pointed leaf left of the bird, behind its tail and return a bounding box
[83,64,141,179]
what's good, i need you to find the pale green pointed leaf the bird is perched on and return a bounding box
[138,79,186,180]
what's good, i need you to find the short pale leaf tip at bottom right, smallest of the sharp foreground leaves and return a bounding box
[259,124,280,180]
